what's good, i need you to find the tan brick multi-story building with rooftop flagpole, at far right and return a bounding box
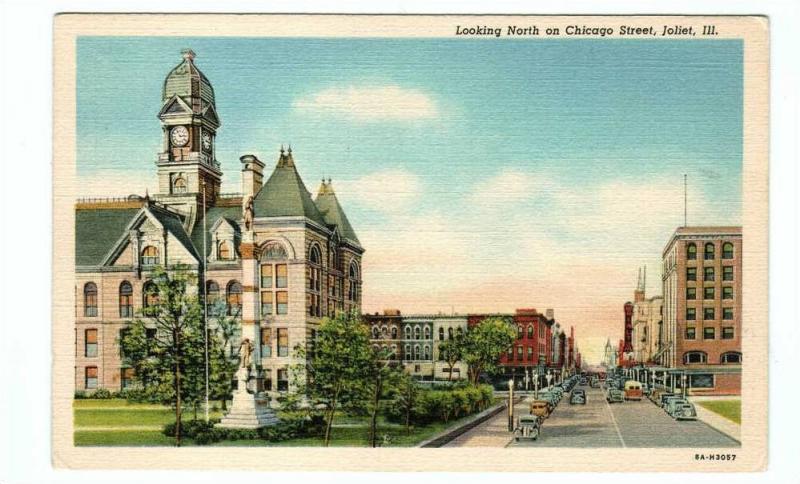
[656,227,742,394]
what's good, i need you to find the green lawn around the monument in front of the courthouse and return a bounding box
[73,399,476,447]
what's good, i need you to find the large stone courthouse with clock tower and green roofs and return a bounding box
[75,50,364,391]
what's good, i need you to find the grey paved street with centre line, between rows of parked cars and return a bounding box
[448,387,739,448]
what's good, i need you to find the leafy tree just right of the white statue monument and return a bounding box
[292,311,374,447]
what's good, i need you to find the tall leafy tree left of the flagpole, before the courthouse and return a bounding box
[120,267,205,446]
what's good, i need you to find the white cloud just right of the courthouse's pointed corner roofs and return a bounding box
[334,168,422,213]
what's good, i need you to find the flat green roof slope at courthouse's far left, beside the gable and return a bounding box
[75,208,141,266]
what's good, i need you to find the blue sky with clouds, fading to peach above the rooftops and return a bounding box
[77,37,742,364]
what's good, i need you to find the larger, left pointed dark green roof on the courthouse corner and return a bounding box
[253,149,325,226]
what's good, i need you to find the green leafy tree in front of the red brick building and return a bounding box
[463,316,517,385]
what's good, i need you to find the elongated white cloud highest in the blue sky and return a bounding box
[293,85,439,121]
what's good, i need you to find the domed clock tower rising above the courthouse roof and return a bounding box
[156,49,222,211]
